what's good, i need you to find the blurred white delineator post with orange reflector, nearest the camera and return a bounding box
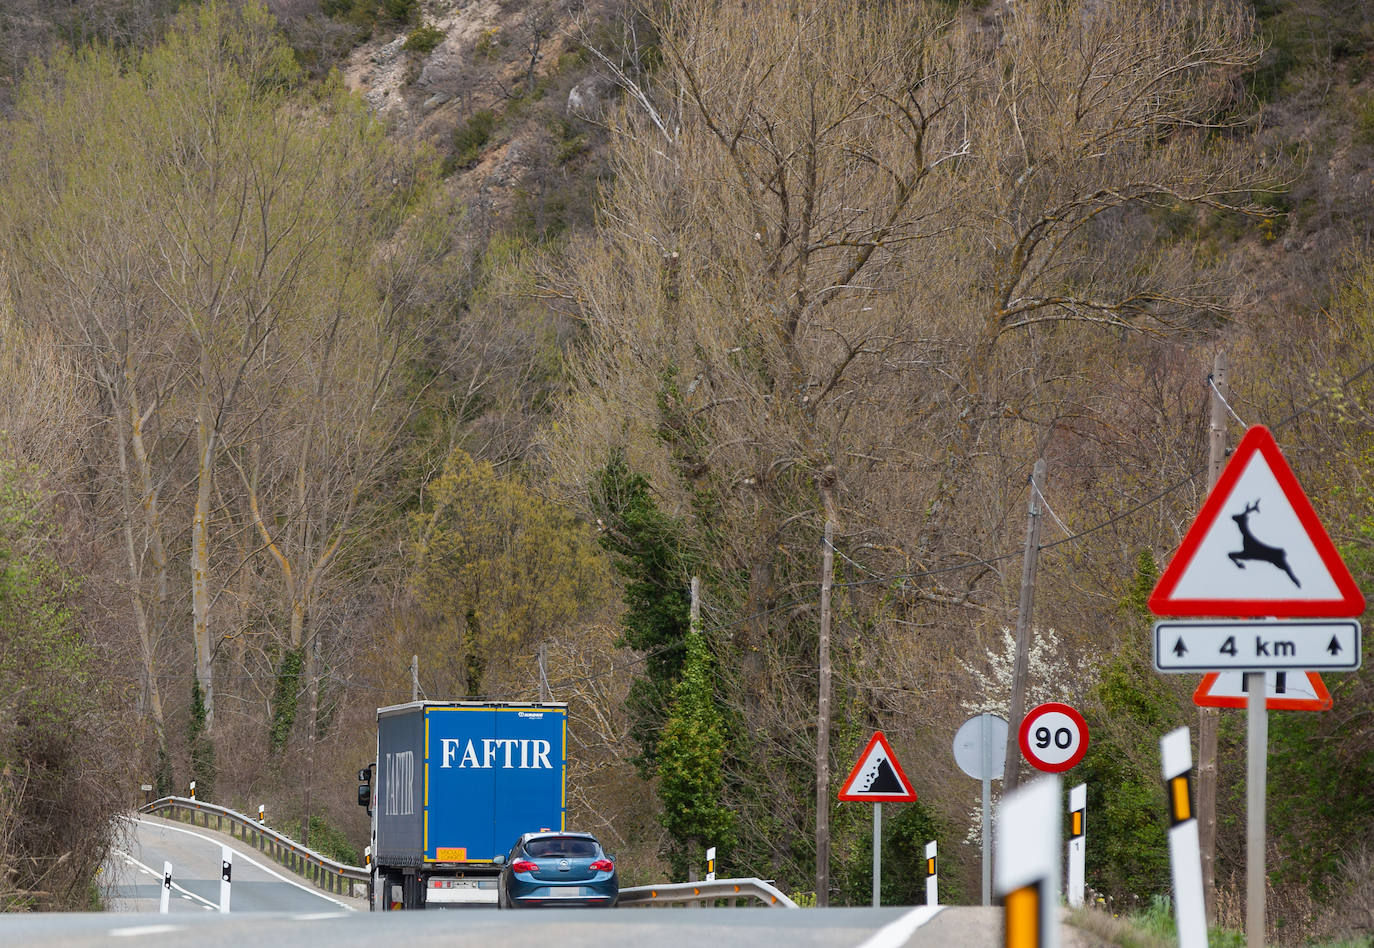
[993,774,1063,948]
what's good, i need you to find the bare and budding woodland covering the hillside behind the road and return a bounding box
[0,0,1374,938]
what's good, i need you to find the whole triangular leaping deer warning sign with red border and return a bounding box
[1149,425,1364,615]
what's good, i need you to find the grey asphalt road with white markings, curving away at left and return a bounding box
[0,816,1092,948]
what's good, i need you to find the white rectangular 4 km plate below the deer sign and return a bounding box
[1154,620,1360,673]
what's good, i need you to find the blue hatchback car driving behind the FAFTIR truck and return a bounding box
[497,833,620,908]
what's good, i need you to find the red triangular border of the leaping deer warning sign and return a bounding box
[1149,425,1364,618]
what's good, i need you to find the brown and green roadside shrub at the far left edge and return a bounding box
[0,450,122,911]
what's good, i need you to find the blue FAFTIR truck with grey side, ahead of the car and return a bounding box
[359,701,567,911]
